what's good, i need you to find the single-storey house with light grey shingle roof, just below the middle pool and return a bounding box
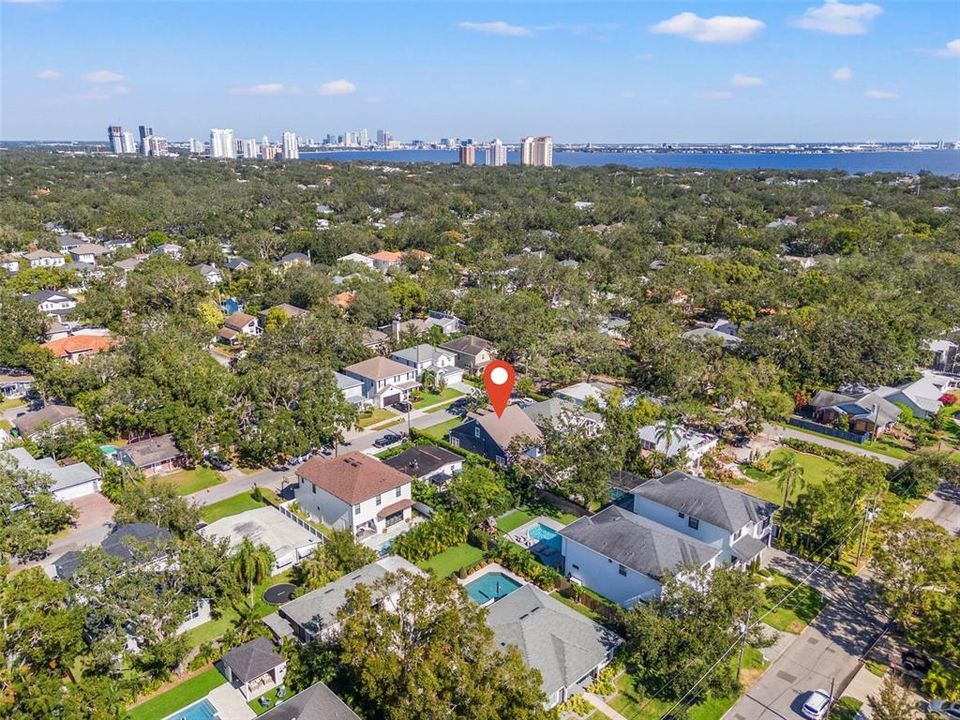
[487,585,623,709]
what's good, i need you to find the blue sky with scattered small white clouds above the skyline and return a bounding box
[0,0,960,142]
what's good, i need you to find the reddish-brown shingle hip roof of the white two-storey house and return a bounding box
[297,452,410,505]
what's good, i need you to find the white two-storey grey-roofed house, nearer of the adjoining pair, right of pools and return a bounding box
[559,505,721,608]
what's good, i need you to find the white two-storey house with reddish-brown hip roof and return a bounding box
[294,452,413,539]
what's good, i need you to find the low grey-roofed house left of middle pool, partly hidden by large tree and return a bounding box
[263,555,424,643]
